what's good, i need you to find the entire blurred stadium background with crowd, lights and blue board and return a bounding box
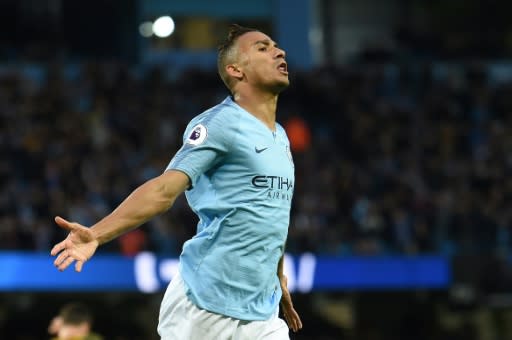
[0,0,512,340]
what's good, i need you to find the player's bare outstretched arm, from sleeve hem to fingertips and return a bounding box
[51,170,189,272]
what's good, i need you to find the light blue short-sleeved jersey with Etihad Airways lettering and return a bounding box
[167,97,294,320]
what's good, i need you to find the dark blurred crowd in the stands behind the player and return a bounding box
[0,63,512,256]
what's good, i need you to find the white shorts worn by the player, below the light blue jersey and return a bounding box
[158,273,290,340]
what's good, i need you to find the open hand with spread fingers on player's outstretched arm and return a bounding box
[50,216,99,272]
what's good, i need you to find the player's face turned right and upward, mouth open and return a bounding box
[238,32,290,93]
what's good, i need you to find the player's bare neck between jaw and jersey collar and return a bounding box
[233,92,278,131]
